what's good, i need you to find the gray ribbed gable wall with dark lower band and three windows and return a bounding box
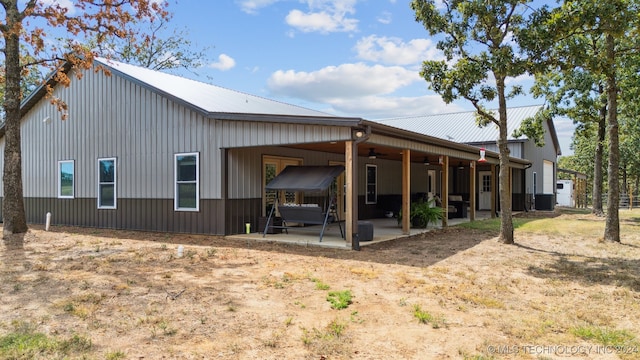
[0,65,224,233]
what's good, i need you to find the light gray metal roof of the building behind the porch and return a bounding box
[372,105,542,143]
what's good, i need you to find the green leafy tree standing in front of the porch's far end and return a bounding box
[411,0,542,244]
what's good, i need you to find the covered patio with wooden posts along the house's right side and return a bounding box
[221,118,531,250]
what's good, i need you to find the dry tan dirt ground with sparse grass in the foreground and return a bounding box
[0,213,640,359]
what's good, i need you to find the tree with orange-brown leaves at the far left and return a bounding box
[0,0,167,237]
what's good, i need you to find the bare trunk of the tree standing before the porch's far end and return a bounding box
[496,76,515,244]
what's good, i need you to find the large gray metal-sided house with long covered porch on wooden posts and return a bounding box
[0,59,530,244]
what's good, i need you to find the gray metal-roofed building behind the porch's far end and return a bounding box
[376,106,561,210]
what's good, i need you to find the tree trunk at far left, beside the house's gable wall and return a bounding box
[2,2,28,238]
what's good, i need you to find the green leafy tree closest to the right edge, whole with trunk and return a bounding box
[526,0,639,242]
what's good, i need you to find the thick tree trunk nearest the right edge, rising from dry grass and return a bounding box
[604,34,620,242]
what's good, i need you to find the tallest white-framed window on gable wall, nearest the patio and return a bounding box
[173,153,200,211]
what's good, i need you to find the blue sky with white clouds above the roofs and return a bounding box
[140,0,573,155]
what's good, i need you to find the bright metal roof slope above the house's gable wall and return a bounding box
[95,58,337,118]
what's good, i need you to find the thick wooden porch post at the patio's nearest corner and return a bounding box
[344,141,360,250]
